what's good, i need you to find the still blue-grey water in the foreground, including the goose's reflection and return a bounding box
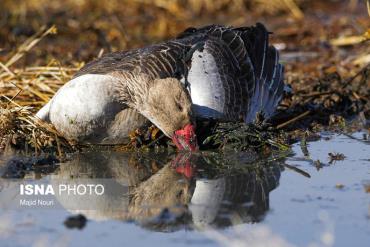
[0,133,370,246]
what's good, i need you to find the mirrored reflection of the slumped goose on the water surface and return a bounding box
[52,152,282,231]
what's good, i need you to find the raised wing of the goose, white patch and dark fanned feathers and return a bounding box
[178,23,284,122]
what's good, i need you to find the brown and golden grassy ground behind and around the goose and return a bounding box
[0,0,370,154]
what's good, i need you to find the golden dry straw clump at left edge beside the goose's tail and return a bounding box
[0,26,78,155]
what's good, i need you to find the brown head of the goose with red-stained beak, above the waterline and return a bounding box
[140,78,198,151]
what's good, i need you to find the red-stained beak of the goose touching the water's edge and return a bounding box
[172,124,198,151]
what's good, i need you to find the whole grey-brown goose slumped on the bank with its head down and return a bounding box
[36,23,284,151]
